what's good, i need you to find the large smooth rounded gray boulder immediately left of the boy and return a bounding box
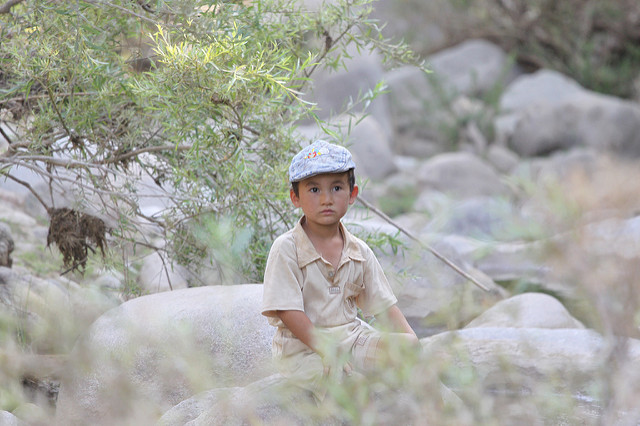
[57,284,275,425]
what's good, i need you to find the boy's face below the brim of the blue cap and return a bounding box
[290,172,358,226]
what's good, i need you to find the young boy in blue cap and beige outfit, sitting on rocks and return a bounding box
[262,141,418,399]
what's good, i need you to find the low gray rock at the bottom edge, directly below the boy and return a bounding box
[162,372,442,426]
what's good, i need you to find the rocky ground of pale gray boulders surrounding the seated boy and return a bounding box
[0,9,640,425]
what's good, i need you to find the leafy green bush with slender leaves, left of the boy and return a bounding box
[0,0,420,281]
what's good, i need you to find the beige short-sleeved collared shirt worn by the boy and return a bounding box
[262,218,397,356]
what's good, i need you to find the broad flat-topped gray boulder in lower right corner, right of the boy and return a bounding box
[421,327,640,425]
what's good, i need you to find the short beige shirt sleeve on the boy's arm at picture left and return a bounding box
[262,233,304,317]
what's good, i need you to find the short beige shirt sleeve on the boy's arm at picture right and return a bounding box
[357,242,398,316]
